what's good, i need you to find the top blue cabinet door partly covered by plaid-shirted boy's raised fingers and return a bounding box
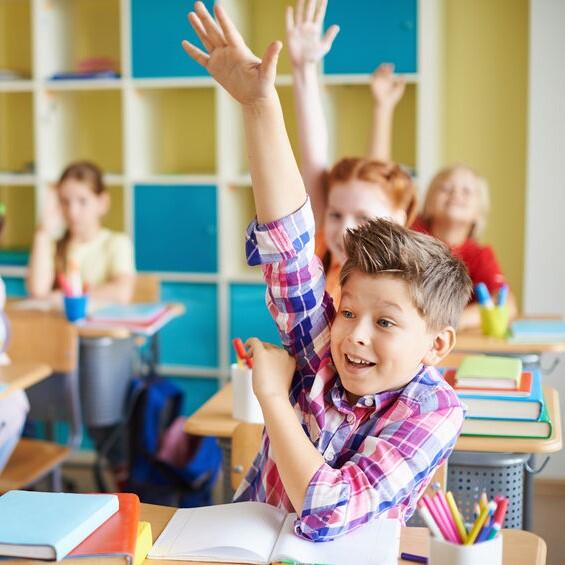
[131,0,214,78]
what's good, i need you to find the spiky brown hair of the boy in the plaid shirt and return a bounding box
[340,218,472,330]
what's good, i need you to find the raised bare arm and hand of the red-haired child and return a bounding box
[286,0,339,227]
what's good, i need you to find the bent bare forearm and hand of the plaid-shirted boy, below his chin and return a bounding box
[247,338,325,515]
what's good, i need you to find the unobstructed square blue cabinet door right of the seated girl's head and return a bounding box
[134,185,218,273]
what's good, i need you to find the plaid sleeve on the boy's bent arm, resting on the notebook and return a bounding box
[295,392,463,541]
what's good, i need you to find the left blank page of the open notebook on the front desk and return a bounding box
[149,502,286,563]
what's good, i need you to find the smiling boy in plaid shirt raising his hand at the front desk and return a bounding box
[183,2,471,541]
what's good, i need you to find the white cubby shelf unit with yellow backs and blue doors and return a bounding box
[0,0,441,408]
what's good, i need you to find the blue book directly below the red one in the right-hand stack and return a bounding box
[444,370,544,420]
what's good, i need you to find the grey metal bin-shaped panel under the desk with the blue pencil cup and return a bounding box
[79,337,135,427]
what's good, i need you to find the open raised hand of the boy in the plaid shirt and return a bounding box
[182,2,282,105]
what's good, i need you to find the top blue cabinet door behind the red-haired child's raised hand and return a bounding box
[324,0,418,74]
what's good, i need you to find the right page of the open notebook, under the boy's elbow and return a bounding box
[271,514,400,565]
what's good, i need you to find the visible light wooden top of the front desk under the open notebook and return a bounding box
[139,504,547,565]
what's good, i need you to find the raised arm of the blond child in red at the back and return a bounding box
[369,64,406,162]
